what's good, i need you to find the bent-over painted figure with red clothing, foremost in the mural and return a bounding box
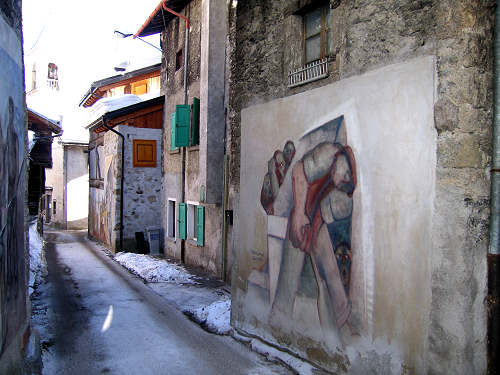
[289,142,356,336]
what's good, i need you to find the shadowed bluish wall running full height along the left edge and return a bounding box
[0,0,29,375]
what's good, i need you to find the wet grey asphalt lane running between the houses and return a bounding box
[32,231,289,375]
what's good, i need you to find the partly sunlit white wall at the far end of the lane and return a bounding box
[64,145,89,229]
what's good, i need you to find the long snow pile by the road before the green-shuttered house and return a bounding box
[115,252,196,284]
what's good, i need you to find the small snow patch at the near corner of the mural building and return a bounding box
[184,298,233,335]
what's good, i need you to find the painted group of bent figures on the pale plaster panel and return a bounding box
[260,116,359,346]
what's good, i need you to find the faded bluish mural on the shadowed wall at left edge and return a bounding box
[0,49,25,350]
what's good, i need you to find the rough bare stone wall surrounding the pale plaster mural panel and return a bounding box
[229,0,494,374]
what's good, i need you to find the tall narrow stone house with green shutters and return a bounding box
[136,0,230,278]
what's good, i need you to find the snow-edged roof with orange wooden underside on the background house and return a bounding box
[79,63,161,107]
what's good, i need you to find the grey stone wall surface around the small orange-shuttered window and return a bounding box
[116,125,162,251]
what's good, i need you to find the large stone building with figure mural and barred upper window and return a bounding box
[228,0,495,374]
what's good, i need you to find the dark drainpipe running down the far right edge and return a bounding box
[487,1,500,374]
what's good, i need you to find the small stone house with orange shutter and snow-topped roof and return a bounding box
[87,96,164,252]
